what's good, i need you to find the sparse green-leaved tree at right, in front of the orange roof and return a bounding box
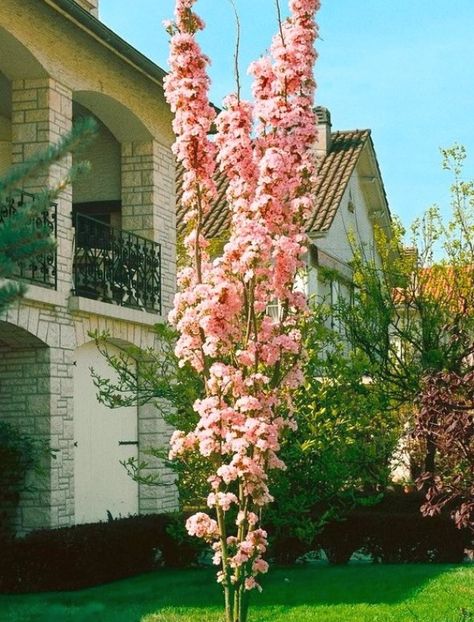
[337,145,474,528]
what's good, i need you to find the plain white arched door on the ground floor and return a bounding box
[74,343,138,523]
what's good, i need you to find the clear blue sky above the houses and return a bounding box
[100,0,474,229]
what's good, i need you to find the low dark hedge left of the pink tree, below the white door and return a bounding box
[0,515,201,593]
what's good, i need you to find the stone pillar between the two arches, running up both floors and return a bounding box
[12,78,75,529]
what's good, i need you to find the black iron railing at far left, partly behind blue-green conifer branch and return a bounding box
[0,191,58,289]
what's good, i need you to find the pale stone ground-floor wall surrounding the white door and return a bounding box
[0,288,178,533]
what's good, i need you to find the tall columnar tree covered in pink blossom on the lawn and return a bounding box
[165,0,319,622]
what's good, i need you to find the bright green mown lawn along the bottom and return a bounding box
[0,565,474,622]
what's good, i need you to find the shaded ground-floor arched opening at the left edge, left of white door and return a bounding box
[0,322,51,533]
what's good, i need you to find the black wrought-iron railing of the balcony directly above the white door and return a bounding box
[73,213,161,313]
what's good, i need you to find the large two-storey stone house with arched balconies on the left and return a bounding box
[0,0,177,533]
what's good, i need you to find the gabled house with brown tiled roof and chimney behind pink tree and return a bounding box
[177,107,391,314]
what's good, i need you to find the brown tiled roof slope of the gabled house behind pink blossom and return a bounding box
[176,130,370,238]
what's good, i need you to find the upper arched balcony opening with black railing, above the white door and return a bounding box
[72,91,161,312]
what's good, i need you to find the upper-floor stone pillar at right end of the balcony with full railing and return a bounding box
[122,141,176,317]
